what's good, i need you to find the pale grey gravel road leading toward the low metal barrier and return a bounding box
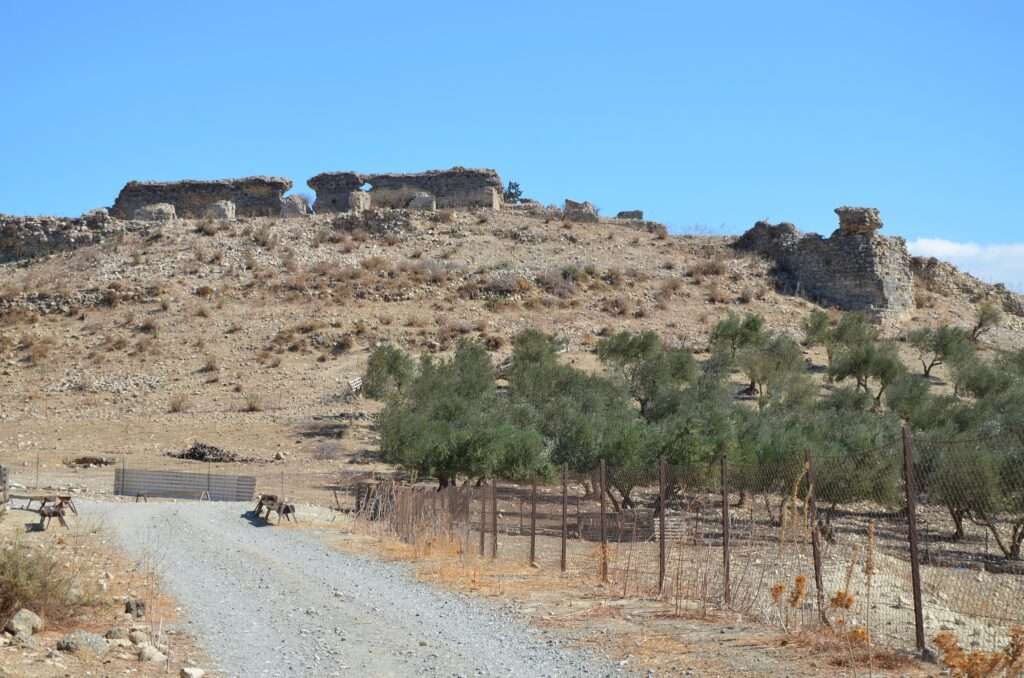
[82,502,624,678]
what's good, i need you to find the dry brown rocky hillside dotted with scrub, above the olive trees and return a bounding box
[0,206,1024,483]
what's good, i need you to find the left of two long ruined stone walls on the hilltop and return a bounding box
[111,176,292,219]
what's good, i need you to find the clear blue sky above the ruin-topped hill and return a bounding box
[0,0,1024,285]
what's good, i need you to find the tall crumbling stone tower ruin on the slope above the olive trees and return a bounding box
[735,207,913,313]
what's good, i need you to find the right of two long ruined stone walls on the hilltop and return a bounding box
[307,167,502,212]
